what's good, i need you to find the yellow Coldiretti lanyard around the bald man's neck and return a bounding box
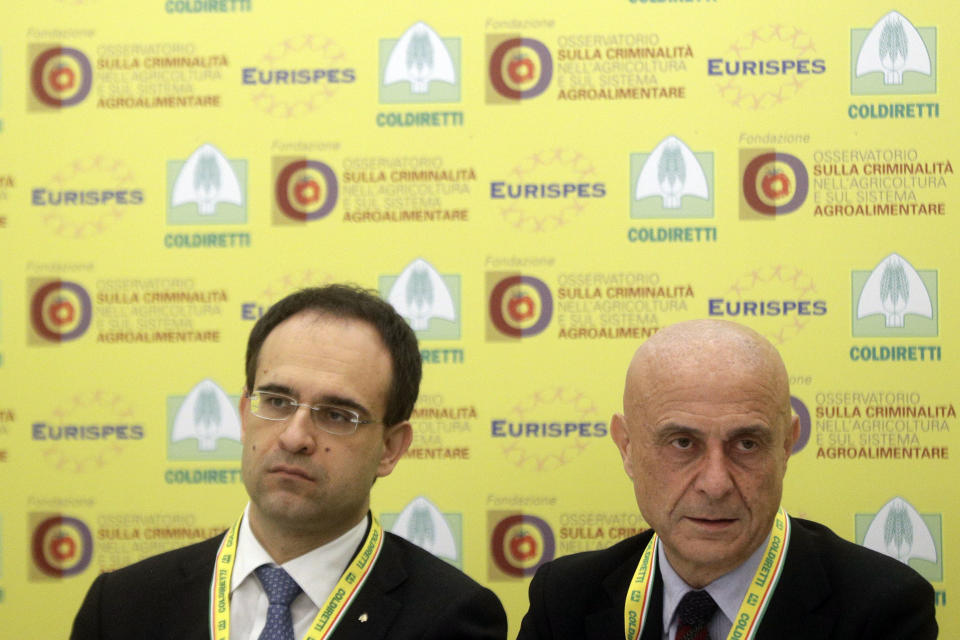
[623,507,790,640]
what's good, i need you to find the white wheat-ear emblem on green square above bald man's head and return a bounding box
[630,136,713,218]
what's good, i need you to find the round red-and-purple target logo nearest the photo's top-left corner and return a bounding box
[30,47,93,108]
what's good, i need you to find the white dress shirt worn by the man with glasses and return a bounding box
[230,503,368,640]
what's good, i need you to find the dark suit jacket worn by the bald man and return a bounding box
[518,518,937,640]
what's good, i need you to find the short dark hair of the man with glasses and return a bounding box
[246,284,423,425]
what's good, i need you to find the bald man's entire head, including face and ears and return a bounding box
[610,320,800,588]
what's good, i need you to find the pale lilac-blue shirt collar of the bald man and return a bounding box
[657,534,770,629]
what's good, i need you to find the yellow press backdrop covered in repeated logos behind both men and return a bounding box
[0,0,960,637]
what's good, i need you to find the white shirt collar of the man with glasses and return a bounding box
[230,503,370,607]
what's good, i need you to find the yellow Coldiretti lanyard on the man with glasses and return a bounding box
[210,516,383,640]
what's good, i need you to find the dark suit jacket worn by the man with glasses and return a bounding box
[70,532,507,640]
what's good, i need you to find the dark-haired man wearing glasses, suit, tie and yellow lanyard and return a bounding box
[71,285,506,640]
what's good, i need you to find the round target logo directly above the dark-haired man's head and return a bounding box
[276,160,339,222]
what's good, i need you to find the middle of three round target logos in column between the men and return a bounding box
[490,275,553,338]
